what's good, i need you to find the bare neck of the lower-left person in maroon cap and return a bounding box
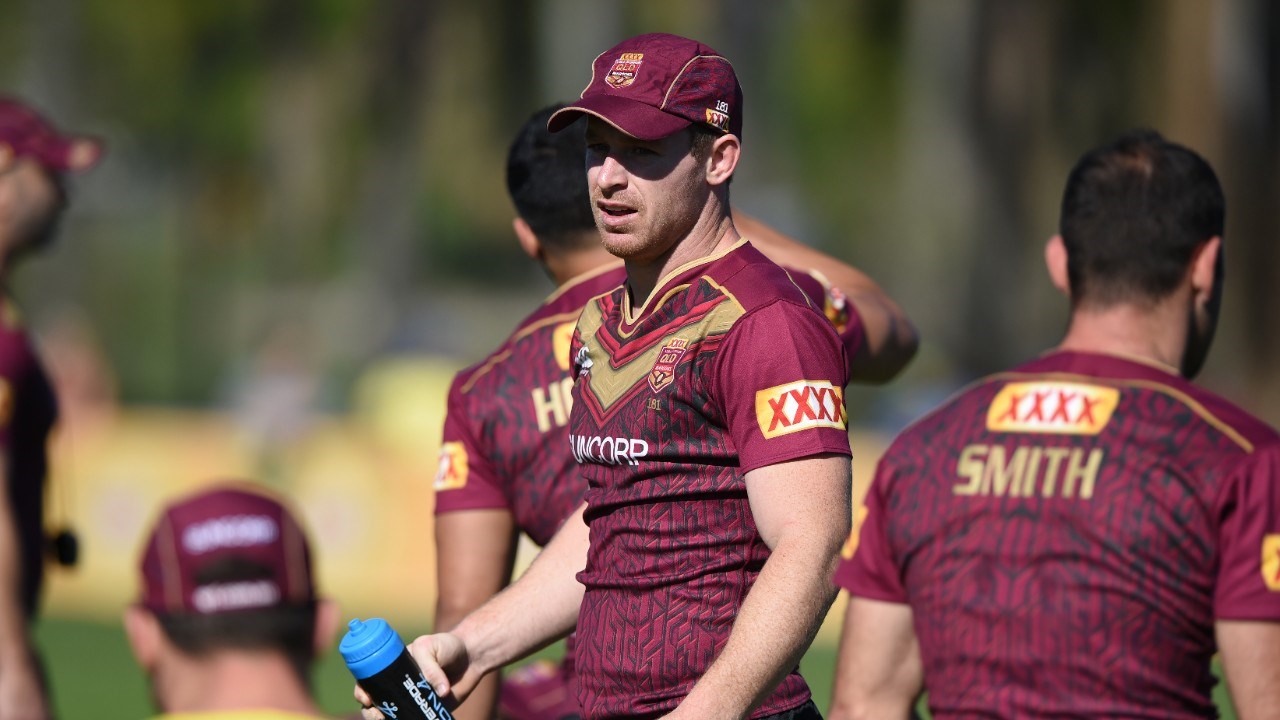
[155,651,323,717]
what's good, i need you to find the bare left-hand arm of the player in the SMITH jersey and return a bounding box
[831,597,924,720]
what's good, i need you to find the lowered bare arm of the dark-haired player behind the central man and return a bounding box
[435,510,517,720]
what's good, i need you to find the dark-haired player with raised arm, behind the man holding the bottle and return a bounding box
[435,105,916,720]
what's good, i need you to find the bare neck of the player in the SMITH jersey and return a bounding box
[1059,293,1188,374]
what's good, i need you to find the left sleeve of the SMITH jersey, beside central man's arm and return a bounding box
[836,459,906,602]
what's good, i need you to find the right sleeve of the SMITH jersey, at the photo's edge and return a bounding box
[1213,443,1280,621]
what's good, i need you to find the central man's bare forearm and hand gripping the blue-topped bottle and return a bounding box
[356,505,590,719]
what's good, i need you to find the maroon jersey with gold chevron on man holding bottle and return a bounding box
[568,241,849,717]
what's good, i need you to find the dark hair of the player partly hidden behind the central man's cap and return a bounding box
[507,104,599,252]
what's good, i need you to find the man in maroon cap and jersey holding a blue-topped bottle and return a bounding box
[368,35,850,719]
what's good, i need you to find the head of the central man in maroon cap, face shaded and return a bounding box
[548,33,742,269]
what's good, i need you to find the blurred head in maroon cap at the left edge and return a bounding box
[0,97,102,258]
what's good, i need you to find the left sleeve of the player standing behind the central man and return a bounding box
[434,374,509,515]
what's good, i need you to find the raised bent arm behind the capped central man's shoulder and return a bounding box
[733,213,920,383]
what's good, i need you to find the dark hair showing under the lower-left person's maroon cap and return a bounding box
[156,557,316,687]
